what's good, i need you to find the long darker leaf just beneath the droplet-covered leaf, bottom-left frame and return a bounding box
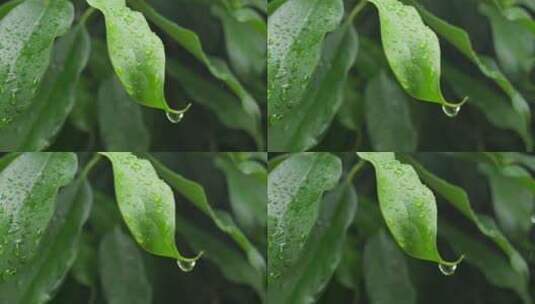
[0,177,93,304]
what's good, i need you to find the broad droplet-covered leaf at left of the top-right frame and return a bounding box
[268,0,344,123]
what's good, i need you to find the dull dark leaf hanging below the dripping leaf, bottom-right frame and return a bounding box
[363,230,416,304]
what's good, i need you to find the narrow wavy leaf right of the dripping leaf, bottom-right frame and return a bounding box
[401,157,529,277]
